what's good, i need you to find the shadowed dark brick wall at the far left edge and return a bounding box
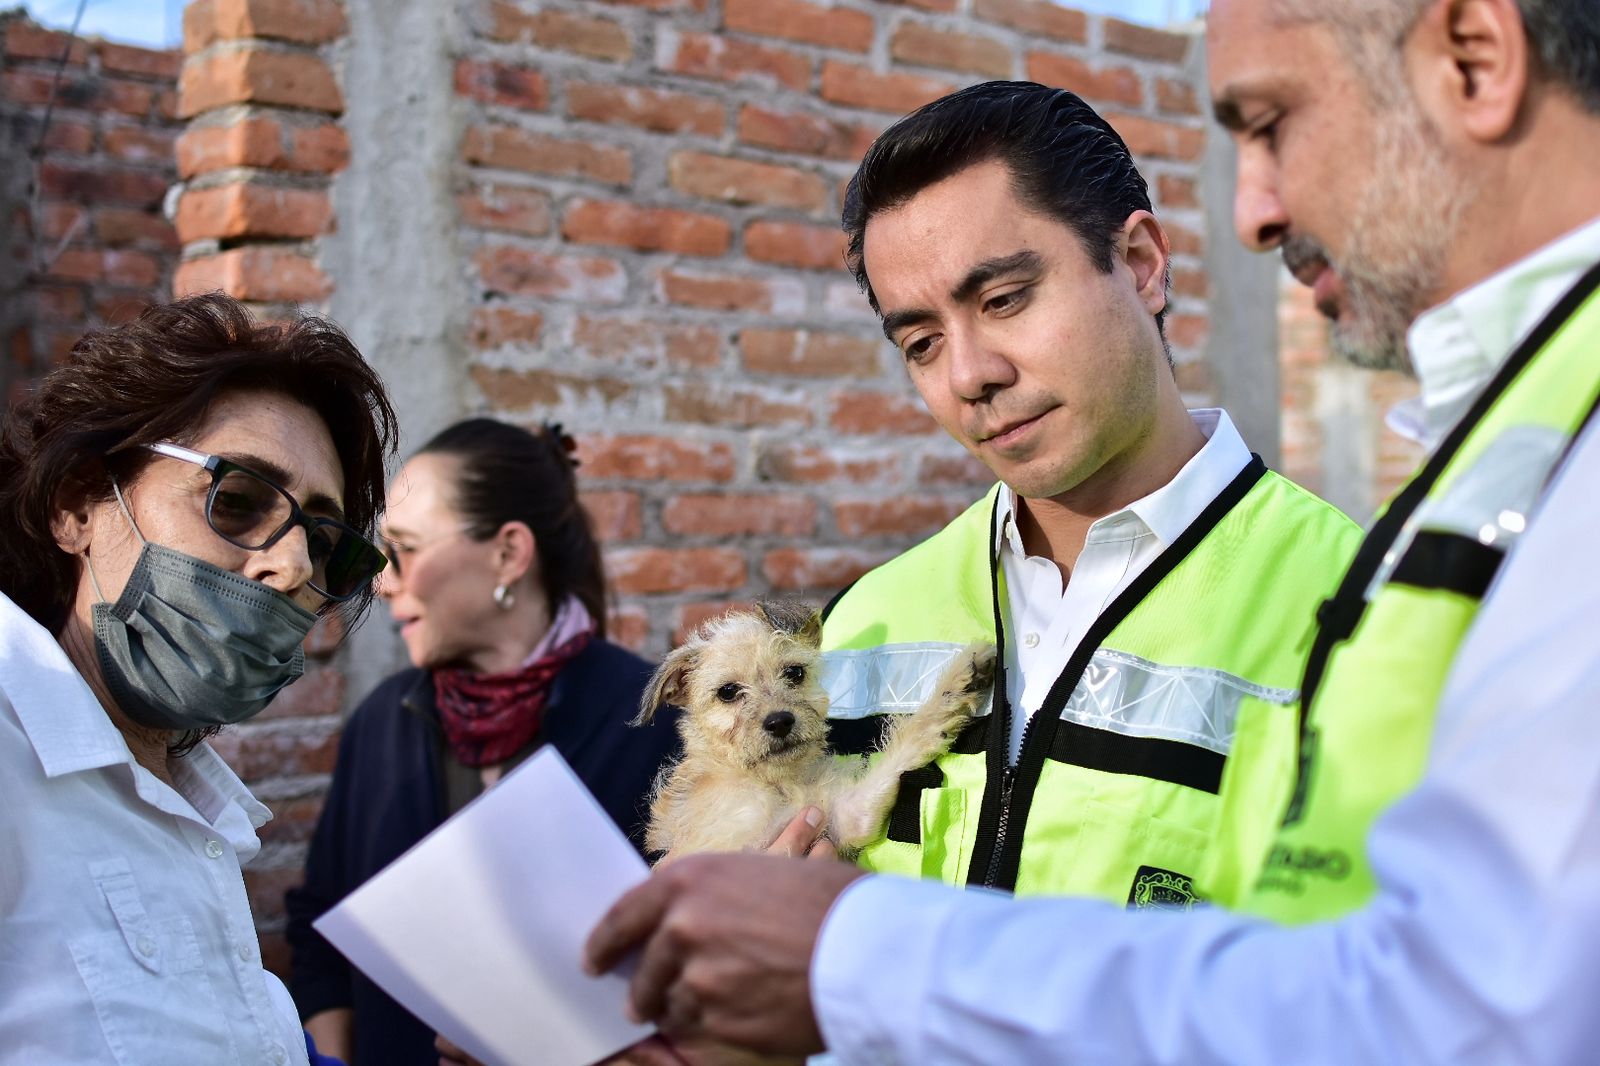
[0,13,181,404]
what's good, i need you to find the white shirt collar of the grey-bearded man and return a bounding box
[1387,218,1600,448]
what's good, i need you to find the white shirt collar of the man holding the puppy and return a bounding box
[994,407,1250,559]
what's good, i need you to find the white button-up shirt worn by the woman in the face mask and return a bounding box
[0,595,306,1066]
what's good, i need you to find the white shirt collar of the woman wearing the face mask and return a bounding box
[0,594,272,860]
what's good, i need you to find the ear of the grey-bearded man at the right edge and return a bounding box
[1405,0,1533,144]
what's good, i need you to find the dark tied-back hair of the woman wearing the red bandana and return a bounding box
[418,418,605,637]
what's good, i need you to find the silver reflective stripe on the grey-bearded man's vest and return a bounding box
[1366,426,1568,600]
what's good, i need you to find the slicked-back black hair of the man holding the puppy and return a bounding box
[840,82,1166,323]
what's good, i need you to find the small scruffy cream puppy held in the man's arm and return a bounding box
[637,603,995,858]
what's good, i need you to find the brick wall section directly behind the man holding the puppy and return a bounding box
[454,0,1210,653]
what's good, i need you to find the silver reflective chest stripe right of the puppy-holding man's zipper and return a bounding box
[1061,648,1299,755]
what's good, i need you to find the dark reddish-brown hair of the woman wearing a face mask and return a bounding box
[0,293,397,632]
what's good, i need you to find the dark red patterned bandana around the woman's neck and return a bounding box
[434,629,594,767]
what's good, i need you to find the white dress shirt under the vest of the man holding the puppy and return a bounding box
[994,408,1250,762]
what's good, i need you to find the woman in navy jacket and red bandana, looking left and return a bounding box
[288,418,677,1066]
